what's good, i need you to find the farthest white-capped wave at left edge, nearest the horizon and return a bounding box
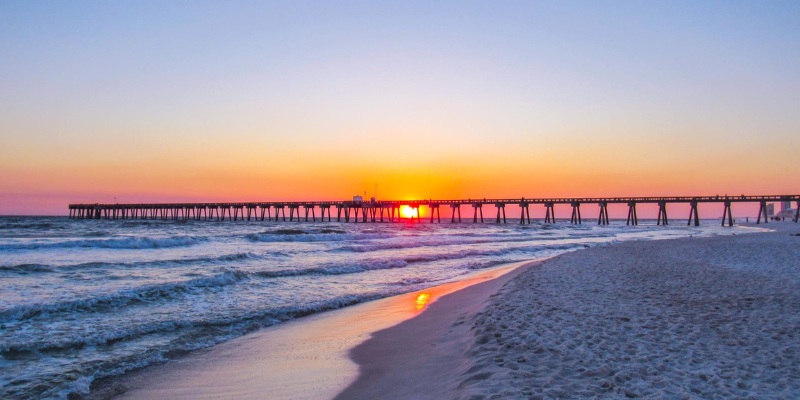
[0,236,208,250]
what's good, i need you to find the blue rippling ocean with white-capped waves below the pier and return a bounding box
[0,217,741,399]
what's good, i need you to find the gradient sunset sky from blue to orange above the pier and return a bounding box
[0,1,800,215]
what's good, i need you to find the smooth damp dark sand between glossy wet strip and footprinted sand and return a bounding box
[335,260,544,400]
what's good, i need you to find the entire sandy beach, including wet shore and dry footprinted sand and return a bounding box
[98,224,800,399]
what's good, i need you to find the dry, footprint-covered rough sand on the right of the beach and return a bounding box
[456,223,800,399]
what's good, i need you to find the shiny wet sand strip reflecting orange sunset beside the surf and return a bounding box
[98,261,538,399]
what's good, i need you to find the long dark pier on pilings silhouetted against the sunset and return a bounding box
[69,195,800,226]
